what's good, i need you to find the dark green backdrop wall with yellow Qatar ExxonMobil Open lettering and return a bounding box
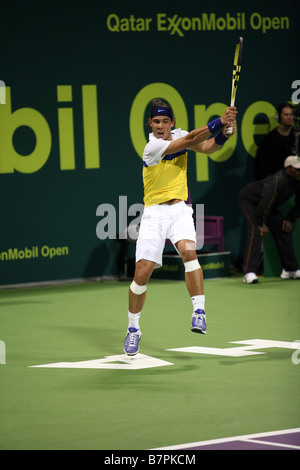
[0,0,300,285]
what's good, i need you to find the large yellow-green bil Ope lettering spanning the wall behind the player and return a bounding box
[0,83,278,177]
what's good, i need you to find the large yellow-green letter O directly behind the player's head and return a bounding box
[129,83,188,158]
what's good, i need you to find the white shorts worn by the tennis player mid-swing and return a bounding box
[136,201,196,268]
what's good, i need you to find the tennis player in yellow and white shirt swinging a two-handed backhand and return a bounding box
[124,99,237,356]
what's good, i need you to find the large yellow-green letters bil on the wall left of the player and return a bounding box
[0,85,100,174]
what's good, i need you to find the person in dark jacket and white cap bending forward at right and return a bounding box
[238,156,300,284]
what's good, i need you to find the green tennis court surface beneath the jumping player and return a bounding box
[0,277,300,450]
